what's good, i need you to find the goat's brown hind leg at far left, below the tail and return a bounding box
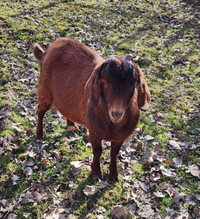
[36,86,52,139]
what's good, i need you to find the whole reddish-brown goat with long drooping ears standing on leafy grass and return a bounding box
[34,38,150,179]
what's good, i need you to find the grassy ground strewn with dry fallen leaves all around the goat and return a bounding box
[0,0,200,218]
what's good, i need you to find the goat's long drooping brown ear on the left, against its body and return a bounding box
[85,65,102,107]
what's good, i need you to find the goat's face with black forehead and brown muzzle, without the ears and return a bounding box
[101,57,137,122]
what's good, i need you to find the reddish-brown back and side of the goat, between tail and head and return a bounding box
[39,38,103,126]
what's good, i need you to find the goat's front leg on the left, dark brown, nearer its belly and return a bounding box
[89,134,102,178]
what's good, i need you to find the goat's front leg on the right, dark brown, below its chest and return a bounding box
[109,141,123,180]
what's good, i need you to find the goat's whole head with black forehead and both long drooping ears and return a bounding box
[86,55,150,123]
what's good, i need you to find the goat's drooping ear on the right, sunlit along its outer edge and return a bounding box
[137,66,150,111]
